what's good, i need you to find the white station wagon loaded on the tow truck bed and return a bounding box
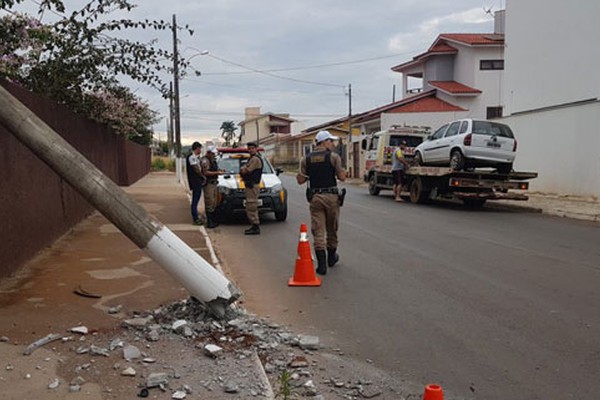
[415,119,517,174]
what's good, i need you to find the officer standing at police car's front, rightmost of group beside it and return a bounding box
[240,142,263,235]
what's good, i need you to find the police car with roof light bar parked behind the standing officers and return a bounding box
[216,147,287,221]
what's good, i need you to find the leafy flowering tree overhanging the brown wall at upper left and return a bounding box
[0,0,193,144]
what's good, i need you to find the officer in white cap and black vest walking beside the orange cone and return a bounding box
[296,131,346,275]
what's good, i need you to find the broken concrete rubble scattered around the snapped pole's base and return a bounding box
[5,298,394,400]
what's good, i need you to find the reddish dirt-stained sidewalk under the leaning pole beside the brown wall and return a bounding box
[0,173,273,400]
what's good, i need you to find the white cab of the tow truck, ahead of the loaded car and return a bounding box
[361,125,431,182]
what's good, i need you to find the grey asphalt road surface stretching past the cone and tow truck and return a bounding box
[214,177,600,400]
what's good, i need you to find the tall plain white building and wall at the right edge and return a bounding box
[502,0,600,197]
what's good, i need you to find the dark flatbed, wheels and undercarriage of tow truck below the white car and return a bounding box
[366,166,538,208]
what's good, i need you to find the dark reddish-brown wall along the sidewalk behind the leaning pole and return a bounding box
[0,78,150,277]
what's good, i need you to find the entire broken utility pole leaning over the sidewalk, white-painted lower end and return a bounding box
[0,86,240,316]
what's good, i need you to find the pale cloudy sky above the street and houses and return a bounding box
[5,0,505,145]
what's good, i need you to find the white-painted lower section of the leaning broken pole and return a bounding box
[144,226,237,302]
